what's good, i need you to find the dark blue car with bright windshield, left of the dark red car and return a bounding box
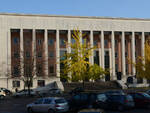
[93,93,134,111]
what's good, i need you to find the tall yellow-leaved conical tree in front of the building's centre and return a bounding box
[61,30,105,84]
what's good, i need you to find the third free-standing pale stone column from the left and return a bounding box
[44,29,49,76]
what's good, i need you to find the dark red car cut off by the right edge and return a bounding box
[129,92,150,108]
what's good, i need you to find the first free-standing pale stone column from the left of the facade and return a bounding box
[20,29,24,76]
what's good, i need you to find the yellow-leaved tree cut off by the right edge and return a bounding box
[129,39,150,80]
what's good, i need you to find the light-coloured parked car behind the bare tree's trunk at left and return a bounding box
[13,89,36,97]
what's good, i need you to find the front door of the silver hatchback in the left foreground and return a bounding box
[32,98,44,112]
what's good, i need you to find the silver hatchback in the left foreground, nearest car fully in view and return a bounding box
[27,97,69,113]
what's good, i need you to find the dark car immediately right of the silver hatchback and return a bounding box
[68,93,96,111]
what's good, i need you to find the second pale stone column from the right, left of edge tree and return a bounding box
[131,32,135,75]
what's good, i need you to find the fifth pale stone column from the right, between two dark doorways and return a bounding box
[101,31,105,68]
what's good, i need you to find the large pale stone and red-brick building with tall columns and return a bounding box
[0,14,150,89]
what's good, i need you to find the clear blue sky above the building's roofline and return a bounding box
[0,0,150,18]
